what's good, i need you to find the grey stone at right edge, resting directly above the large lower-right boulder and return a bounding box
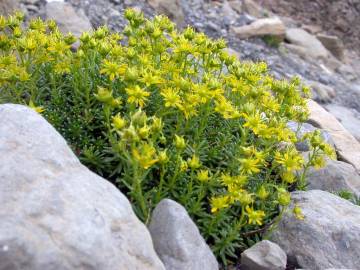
[306,159,360,197]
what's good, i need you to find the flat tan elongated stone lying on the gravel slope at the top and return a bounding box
[232,17,285,39]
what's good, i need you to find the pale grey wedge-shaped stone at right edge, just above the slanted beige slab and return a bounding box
[325,104,360,142]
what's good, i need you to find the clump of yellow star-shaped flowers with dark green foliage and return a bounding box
[0,10,333,264]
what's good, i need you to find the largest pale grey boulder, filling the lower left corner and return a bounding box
[0,104,165,270]
